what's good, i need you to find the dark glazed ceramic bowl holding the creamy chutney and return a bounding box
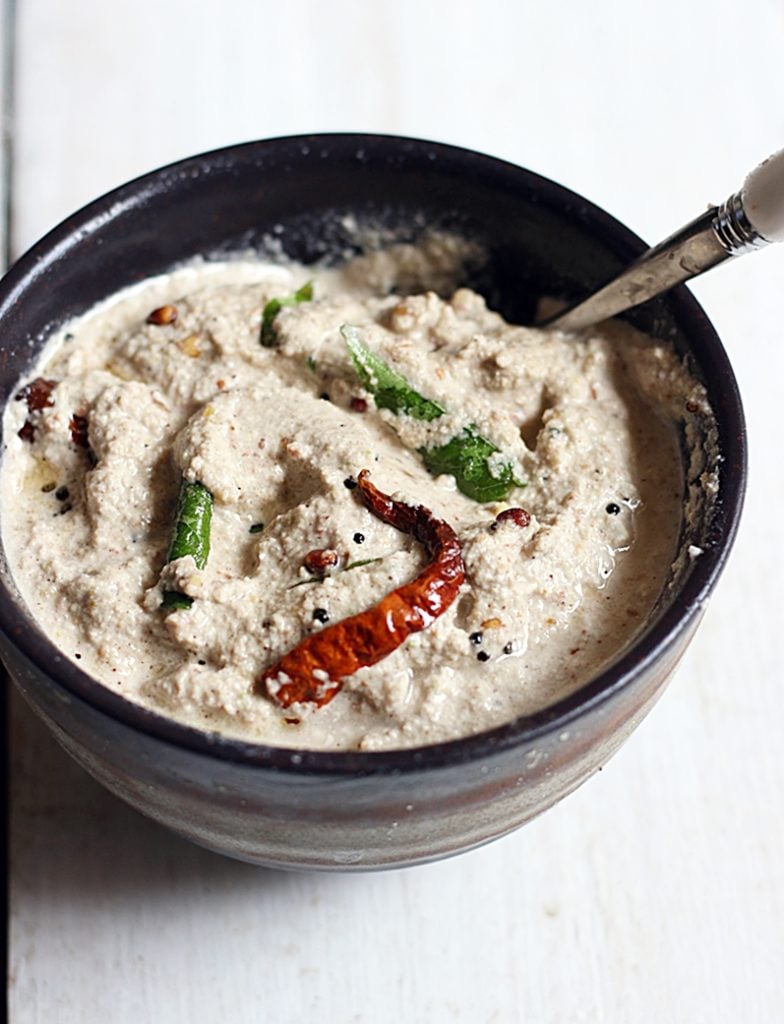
[0,135,746,869]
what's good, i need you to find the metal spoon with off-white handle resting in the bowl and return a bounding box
[538,150,784,331]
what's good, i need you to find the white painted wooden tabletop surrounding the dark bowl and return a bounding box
[9,0,784,1024]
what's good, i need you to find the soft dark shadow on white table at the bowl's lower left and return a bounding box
[9,692,354,901]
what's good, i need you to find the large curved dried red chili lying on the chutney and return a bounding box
[256,469,466,708]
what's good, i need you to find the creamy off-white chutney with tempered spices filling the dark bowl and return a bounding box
[2,247,714,751]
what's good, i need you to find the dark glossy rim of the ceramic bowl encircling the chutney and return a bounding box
[0,132,747,776]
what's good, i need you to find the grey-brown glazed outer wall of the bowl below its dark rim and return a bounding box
[0,622,696,870]
